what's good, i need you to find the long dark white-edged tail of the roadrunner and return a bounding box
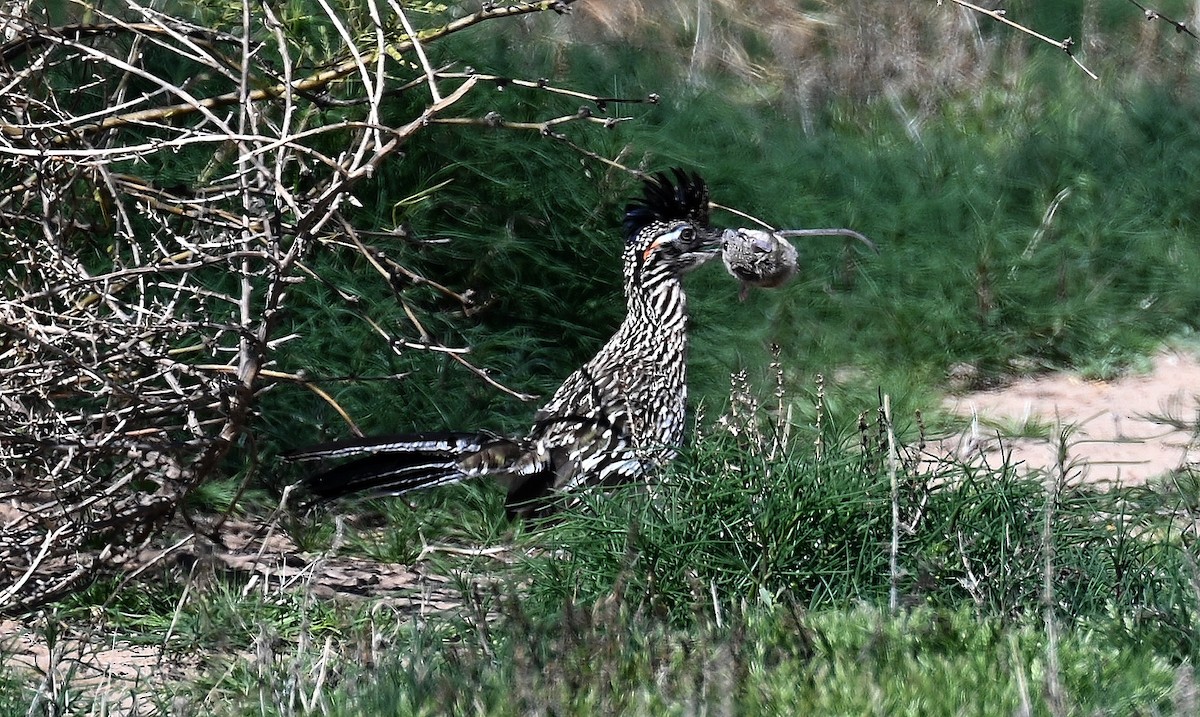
[284,433,496,502]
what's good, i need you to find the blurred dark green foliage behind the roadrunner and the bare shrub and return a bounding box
[263,7,1200,450]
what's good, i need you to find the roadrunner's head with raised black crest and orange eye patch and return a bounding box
[624,169,721,282]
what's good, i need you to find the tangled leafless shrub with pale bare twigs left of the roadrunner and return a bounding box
[0,0,638,611]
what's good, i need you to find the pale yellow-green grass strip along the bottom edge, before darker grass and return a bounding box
[332,603,1194,716]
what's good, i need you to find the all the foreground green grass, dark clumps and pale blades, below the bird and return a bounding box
[7,386,1200,716]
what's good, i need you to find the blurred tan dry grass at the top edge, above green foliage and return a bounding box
[570,0,996,106]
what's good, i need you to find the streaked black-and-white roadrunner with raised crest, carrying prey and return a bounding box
[290,169,721,517]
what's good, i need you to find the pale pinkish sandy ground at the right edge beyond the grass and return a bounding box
[934,350,1200,486]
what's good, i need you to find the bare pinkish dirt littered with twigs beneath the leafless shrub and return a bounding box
[0,520,496,715]
